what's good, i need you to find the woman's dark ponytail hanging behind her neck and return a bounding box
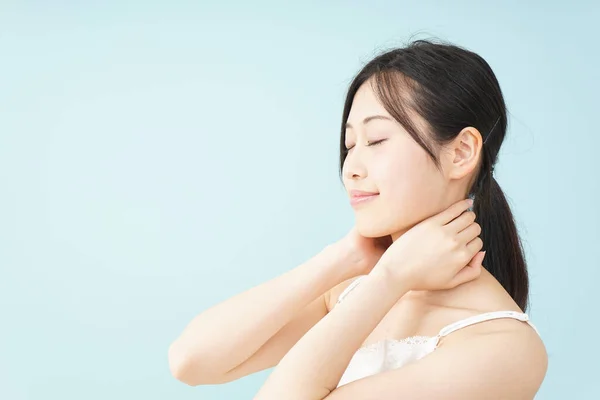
[473,173,529,312]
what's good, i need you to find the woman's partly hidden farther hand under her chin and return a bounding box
[335,227,392,276]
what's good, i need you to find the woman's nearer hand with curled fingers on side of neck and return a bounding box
[374,200,485,290]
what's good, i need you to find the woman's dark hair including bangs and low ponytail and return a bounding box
[340,40,529,311]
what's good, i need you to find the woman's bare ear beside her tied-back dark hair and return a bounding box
[444,126,483,179]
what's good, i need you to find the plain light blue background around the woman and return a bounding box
[0,0,600,400]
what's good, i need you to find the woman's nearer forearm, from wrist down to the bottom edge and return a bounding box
[255,266,410,400]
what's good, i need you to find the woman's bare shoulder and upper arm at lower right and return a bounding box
[328,320,547,400]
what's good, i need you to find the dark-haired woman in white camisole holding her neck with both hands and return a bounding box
[169,40,547,400]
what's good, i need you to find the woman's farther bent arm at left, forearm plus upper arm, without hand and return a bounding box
[169,245,353,385]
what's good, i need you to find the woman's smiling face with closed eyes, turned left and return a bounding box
[342,81,449,239]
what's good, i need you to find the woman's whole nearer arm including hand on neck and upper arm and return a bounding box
[254,200,545,400]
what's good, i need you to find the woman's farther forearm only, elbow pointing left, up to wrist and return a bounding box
[169,242,351,381]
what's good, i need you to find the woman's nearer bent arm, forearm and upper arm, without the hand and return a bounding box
[254,262,547,400]
